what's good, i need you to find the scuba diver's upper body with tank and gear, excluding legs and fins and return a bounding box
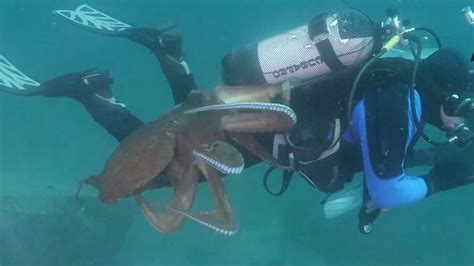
[223,4,474,233]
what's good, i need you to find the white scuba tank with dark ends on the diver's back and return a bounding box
[221,10,379,86]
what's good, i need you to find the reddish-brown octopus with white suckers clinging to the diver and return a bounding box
[76,85,296,235]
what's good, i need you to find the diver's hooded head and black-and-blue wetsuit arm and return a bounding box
[344,49,474,208]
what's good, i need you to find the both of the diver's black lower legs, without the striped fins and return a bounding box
[41,25,198,142]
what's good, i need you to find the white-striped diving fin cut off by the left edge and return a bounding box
[0,55,40,96]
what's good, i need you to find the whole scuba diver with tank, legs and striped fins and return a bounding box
[0,5,474,233]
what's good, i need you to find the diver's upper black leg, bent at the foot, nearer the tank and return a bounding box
[123,28,198,104]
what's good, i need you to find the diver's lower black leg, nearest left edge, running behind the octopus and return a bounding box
[39,70,143,142]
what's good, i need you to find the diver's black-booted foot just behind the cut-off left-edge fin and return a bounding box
[39,69,113,100]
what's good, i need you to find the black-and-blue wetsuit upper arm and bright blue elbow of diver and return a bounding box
[353,88,427,208]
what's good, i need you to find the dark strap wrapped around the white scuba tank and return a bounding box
[308,14,344,72]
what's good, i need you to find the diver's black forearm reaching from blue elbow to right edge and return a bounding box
[423,162,474,195]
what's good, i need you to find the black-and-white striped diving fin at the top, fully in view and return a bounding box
[53,4,132,36]
